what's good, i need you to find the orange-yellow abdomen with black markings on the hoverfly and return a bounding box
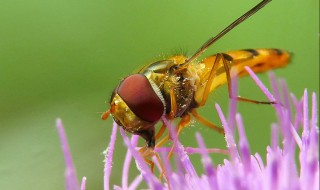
[195,48,290,100]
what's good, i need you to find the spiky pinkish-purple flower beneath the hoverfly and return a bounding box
[57,68,319,190]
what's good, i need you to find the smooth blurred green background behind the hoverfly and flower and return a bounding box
[0,0,319,190]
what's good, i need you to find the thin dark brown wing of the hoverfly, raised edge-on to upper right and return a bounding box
[181,0,271,67]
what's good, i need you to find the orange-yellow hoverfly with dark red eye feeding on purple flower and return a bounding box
[102,0,290,157]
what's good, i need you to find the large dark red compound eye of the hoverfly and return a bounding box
[117,74,164,122]
